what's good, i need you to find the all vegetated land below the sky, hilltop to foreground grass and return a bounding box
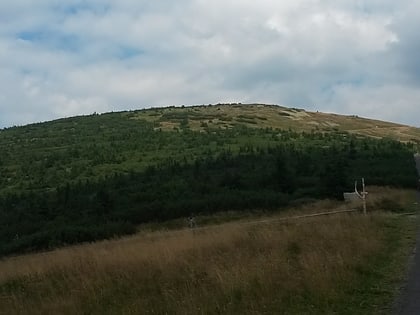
[0,104,420,314]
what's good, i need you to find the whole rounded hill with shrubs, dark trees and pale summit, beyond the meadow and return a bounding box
[0,104,420,255]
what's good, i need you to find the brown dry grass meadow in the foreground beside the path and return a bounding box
[0,191,417,314]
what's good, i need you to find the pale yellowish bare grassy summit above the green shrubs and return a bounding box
[136,104,420,141]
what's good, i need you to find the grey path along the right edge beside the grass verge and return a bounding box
[395,154,420,315]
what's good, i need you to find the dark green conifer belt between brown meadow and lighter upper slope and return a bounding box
[0,132,417,255]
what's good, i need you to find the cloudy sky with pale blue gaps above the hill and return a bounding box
[0,0,420,128]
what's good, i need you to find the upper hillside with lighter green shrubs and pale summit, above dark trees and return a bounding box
[0,104,420,198]
